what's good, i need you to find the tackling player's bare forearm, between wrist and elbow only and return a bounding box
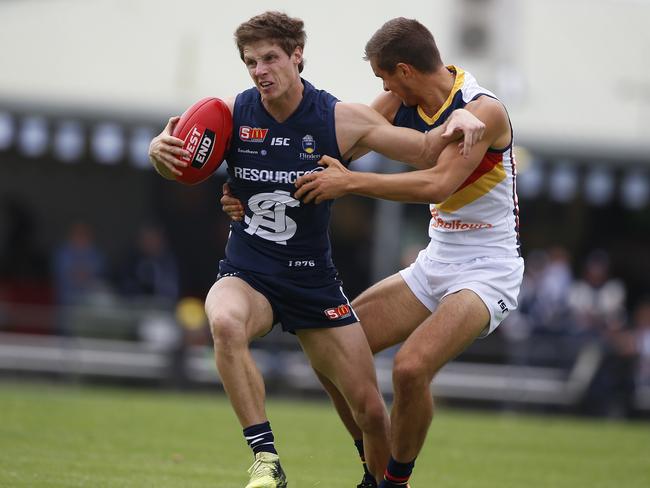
[346,171,442,203]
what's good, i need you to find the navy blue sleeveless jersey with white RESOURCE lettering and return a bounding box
[226,80,342,277]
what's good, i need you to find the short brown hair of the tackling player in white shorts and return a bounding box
[364,17,442,73]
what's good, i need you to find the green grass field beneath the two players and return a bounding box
[0,383,650,488]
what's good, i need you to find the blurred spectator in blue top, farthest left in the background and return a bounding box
[54,222,105,305]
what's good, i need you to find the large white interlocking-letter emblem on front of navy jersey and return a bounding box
[244,190,300,246]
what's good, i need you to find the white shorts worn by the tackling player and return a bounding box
[400,250,524,337]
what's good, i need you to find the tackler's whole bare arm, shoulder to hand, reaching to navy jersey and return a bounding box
[295,97,511,203]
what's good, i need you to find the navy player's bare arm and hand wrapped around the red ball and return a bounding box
[149,97,235,180]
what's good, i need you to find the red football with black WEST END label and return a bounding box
[172,98,232,185]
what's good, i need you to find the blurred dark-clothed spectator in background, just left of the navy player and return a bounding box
[122,225,178,306]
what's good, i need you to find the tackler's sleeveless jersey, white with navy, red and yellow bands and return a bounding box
[394,66,520,262]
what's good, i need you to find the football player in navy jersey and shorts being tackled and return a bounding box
[149,12,483,488]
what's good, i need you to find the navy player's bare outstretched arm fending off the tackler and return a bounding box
[335,103,485,168]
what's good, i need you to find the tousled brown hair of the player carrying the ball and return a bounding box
[235,11,307,72]
